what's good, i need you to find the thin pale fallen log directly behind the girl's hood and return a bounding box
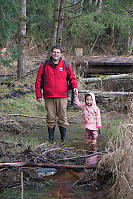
[79,90,133,95]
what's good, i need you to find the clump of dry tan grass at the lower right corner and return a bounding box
[98,116,133,199]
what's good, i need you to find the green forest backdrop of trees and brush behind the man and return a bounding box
[0,0,133,76]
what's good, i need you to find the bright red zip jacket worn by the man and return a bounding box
[35,58,77,98]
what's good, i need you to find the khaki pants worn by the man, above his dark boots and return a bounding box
[45,97,69,128]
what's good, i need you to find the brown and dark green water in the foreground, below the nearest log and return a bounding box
[0,170,100,199]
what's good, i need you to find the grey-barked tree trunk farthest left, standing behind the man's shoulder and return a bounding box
[17,0,26,78]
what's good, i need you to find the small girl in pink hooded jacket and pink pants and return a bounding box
[74,93,101,144]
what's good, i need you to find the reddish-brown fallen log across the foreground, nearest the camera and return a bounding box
[0,162,97,170]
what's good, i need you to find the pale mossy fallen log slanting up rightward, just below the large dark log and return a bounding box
[82,73,133,84]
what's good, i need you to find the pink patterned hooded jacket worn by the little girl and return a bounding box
[74,93,101,130]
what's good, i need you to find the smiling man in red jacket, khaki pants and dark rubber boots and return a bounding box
[35,45,78,140]
